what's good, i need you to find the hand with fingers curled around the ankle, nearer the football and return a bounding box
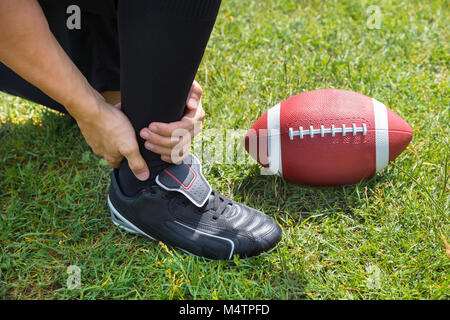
[139,80,205,163]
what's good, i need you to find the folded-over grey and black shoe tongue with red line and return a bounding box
[155,154,212,207]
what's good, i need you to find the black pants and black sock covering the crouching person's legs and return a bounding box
[0,0,221,195]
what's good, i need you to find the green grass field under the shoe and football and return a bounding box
[0,0,450,299]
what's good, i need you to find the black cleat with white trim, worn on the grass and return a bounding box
[108,155,282,260]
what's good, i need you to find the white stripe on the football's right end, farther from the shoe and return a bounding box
[372,98,389,172]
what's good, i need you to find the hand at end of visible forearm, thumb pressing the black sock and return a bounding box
[76,98,150,181]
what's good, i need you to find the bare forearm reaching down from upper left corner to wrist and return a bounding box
[0,0,101,120]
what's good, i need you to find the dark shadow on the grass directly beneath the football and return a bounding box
[233,165,386,224]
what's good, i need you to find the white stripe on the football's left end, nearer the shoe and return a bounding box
[267,103,283,176]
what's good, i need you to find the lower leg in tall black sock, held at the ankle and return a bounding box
[117,0,221,195]
